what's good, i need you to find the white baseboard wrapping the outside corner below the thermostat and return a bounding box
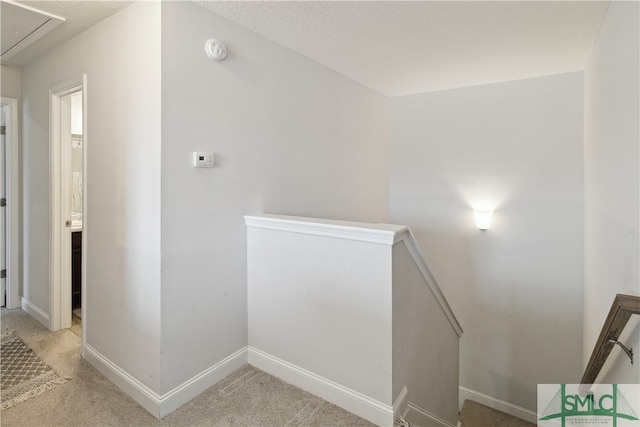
[84,344,247,418]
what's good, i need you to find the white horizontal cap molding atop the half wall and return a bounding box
[244,214,408,245]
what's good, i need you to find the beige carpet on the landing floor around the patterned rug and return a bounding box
[0,309,372,427]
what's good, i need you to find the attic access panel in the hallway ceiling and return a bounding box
[0,0,64,60]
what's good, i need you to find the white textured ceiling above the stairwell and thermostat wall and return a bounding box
[196,0,609,96]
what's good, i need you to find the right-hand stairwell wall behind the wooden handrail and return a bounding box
[583,2,640,383]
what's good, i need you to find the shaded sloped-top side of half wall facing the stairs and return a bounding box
[393,241,460,425]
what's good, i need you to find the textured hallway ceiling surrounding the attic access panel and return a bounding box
[0,0,132,67]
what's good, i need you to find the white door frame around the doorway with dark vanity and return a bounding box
[49,74,87,332]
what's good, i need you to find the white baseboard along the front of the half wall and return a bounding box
[248,346,393,426]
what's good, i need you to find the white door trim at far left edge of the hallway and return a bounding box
[0,97,22,308]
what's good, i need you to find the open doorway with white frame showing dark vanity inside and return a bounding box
[49,76,86,342]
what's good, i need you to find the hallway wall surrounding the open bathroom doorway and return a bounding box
[22,2,160,390]
